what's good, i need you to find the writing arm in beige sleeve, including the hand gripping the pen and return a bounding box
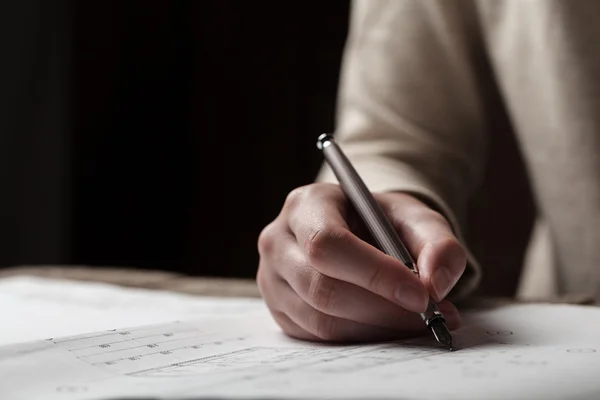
[257,0,484,341]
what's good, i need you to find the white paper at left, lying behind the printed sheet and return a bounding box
[0,277,263,345]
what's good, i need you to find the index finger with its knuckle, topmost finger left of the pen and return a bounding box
[287,185,428,312]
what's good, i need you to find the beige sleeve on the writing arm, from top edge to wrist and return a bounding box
[318,0,486,297]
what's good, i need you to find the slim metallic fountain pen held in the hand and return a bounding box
[317,133,454,351]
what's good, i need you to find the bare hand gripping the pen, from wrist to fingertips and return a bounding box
[257,183,466,341]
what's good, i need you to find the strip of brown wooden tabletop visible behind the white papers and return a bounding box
[0,265,592,308]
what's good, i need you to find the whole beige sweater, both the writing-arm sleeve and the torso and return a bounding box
[318,0,600,300]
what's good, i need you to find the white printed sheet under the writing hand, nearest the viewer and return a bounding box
[0,305,600,400]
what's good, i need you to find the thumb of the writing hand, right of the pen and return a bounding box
[377,193,467,302]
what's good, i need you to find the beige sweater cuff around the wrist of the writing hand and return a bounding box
[316,156,481,301]
